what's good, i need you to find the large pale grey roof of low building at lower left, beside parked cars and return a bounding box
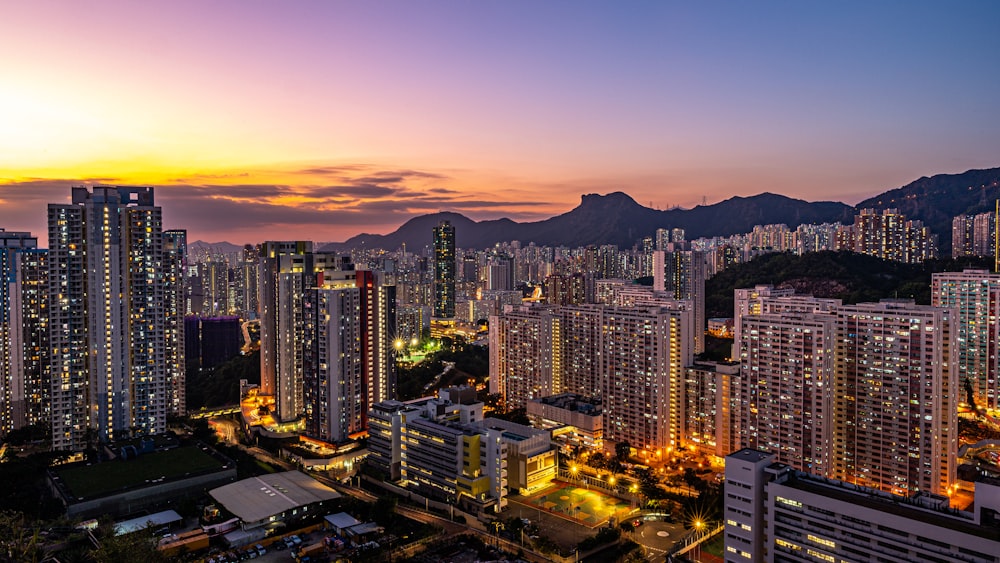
[208,471,340,522]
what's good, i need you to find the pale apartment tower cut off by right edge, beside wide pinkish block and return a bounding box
[931,269,1000,409]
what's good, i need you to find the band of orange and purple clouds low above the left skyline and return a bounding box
[0,163,563,242]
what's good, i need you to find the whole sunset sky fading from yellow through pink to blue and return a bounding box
[0,0,1000,243]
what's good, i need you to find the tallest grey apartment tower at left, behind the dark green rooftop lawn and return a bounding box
[48,187,177,450]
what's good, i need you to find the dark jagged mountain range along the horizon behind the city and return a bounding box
[323,168,1000,255]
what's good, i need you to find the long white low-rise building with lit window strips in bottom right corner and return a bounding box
[724,448,1000,563]
